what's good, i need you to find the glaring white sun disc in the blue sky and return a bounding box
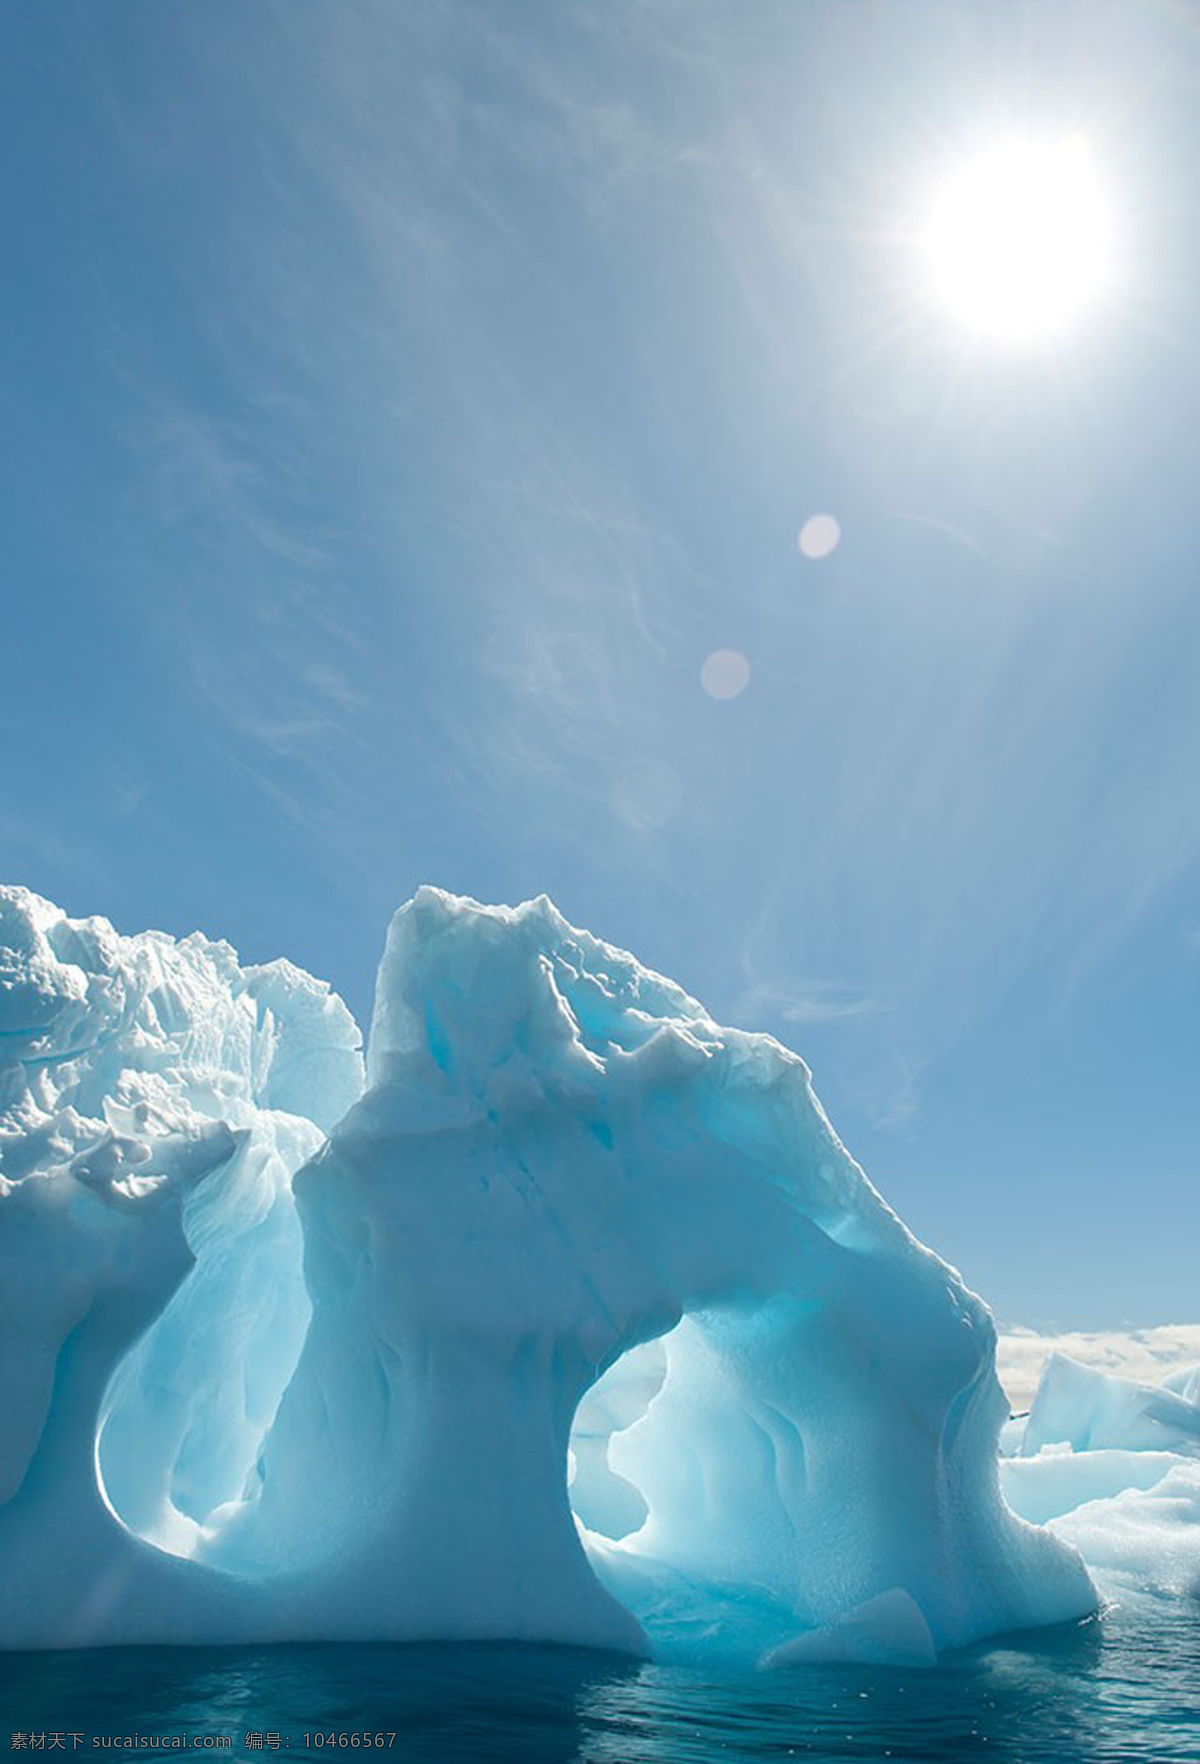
[923,134,1112,342]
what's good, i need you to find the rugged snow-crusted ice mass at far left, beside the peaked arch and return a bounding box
[0,887,362,1644]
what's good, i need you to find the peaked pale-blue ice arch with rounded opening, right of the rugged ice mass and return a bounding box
[199,889,1092,1648]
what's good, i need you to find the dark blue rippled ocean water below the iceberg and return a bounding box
[0,1600,1200,1764]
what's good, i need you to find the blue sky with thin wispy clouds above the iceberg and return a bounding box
[0,0,1200,1327]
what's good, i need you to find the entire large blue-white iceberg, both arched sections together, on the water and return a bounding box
[0,889,1096,1663]
